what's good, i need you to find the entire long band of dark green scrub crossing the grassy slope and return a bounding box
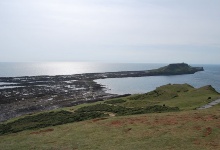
[0,104,179,135]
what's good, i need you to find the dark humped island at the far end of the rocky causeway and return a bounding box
[149,63,204,75]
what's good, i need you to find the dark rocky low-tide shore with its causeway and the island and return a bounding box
[0,64,203,122]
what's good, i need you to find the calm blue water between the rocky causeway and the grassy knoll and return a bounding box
[95,65,220,94]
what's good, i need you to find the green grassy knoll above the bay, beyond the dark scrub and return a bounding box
[116,84,219,110]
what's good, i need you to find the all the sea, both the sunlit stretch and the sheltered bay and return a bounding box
[0,62,220,94]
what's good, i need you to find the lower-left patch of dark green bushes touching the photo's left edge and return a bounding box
[0,110,105,135]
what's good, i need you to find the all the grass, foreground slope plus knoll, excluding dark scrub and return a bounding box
[0,84,220,150]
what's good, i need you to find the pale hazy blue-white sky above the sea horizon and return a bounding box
[0,0,220,64]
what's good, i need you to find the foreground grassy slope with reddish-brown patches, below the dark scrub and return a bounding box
[0,105,220,150]
